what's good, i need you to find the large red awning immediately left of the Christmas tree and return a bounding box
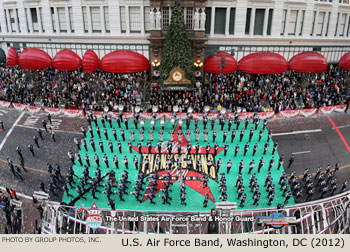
[100,50,150,73]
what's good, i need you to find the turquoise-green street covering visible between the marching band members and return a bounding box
[63,120,295,211]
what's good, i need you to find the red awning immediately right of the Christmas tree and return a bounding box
[204,51,237,74]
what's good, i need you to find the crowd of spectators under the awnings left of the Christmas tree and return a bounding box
[0,66,145,110]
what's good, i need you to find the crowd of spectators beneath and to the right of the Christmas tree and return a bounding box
[151,66,350,113]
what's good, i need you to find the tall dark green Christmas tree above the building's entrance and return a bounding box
[159,0,195,84]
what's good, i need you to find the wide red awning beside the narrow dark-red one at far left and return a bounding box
[18,48,51,70]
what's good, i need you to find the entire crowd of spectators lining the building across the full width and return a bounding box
[0,66,350,113]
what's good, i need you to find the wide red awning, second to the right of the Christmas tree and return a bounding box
[238,52,288,74]
